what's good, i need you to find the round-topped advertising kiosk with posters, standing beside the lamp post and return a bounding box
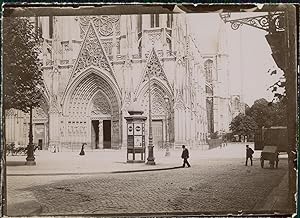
[125,105,147,163]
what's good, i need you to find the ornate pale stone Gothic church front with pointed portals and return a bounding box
[6,14,237,149]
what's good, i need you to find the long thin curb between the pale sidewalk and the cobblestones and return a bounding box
[6,166,182,176]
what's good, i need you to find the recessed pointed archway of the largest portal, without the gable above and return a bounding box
[64,69,121,149]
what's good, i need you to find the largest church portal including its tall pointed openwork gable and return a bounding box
[62,22,121,148]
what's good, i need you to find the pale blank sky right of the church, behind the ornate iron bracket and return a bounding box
[189,13,282,106]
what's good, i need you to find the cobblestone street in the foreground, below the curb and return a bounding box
[8,143,291,215]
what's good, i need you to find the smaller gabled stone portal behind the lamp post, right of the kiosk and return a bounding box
[135,48,174,147]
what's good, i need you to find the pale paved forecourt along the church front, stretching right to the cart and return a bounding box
[7,144,260,176]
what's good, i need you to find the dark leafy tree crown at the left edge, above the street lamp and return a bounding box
[3,17,42,112]
